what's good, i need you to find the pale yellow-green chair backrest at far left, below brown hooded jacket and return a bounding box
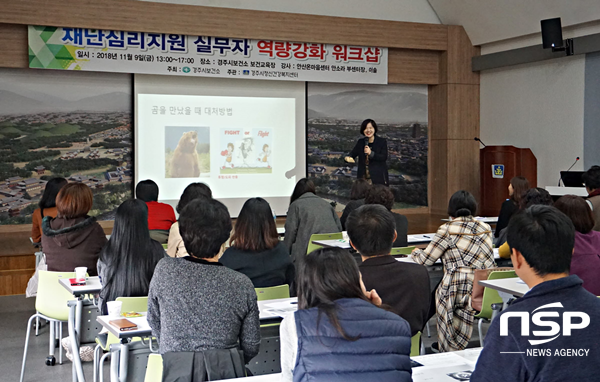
[35,271,75,321]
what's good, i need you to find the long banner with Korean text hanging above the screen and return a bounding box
[29,26,388,84]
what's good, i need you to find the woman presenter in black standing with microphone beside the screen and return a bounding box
[344,119,389,186]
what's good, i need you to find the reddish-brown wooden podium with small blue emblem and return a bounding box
[479,146,537,216]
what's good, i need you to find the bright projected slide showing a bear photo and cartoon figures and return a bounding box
[136,94,304,214]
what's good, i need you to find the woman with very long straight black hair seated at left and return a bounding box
[97,199,165,314]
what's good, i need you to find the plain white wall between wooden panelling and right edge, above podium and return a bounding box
[481,55,585,187]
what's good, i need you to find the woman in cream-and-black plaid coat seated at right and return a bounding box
[412,191,496,351]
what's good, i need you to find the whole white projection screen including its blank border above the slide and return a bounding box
[134,74,306,217]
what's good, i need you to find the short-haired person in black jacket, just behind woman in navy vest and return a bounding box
[347,204,431,336]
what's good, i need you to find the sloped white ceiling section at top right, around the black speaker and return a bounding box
[429,0,600,45]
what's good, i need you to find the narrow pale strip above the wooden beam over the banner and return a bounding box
[143,0,440,23]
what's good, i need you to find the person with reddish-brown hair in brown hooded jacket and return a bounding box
[42,183,106,276]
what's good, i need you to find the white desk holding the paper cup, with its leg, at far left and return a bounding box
[58,276,102,382]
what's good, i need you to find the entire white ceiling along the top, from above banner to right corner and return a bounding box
[142,0,600,47]
